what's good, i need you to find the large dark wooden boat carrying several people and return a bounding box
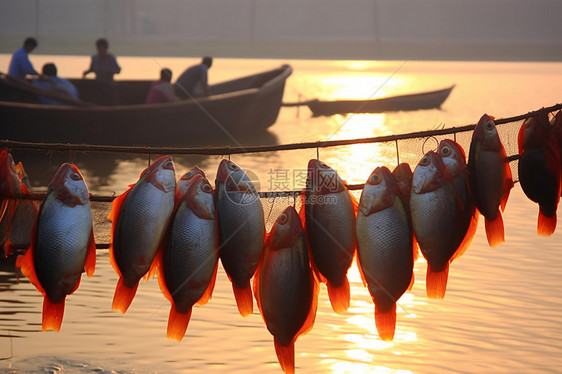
[0,65,292,146]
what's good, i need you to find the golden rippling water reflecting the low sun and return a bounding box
[0,56,562,374]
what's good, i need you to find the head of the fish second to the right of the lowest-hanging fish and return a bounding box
[359,166,399,216]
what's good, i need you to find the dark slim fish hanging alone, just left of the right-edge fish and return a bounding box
[468,114,513,247]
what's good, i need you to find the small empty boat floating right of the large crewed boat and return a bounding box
[284,85,455,117]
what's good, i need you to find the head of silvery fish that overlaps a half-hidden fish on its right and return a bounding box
[412,151,445,194]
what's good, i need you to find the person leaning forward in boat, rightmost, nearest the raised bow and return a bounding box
[174,56,213,99]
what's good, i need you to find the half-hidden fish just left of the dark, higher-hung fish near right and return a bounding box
[437,139,478,260]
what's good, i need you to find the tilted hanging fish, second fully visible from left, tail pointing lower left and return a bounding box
[109,156,176,313]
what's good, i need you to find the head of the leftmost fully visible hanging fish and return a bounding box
[49,162,90,207]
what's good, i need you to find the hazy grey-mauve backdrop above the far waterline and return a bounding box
[0,0,562,61]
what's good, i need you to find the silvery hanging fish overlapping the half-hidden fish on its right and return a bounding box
[410,151,463,298]
